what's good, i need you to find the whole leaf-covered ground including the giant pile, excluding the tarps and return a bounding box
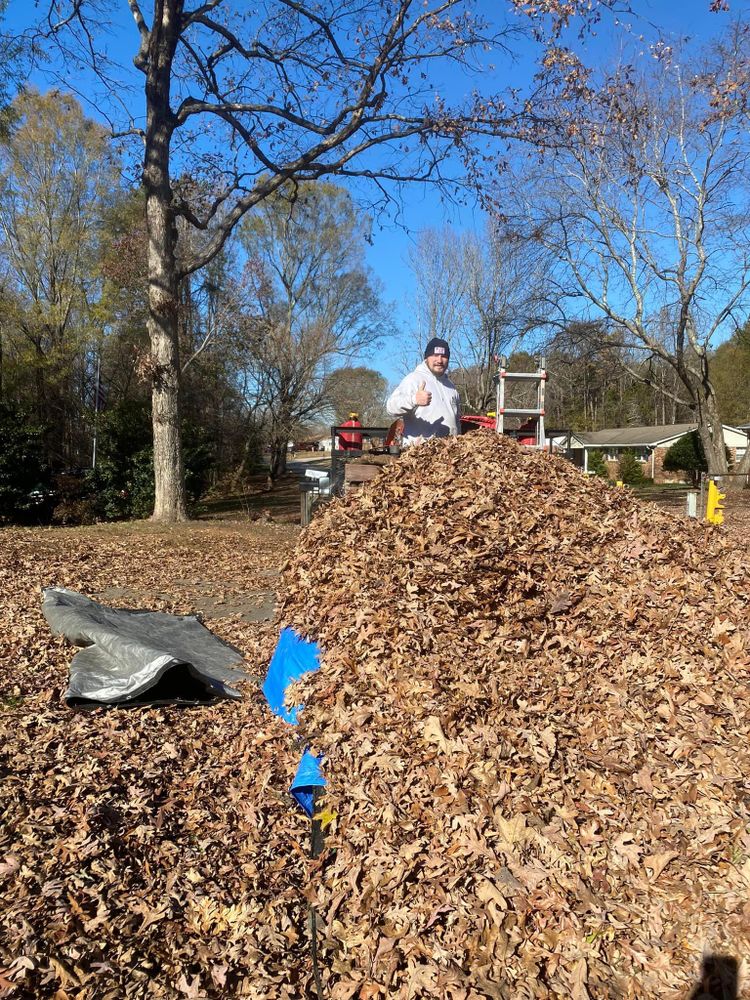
[0,450,750,1000]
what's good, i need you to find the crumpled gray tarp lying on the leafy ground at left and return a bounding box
[42,587,247,705]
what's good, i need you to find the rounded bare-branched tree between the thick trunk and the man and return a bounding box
[240,182,388,478]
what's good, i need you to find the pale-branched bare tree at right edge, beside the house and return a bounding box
[522,48,750,474]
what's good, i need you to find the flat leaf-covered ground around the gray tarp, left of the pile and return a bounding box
[0,524,309,1000]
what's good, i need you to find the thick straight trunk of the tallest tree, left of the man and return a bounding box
[143,0,187,522]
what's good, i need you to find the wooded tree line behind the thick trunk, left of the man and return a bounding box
[0,90,388,520]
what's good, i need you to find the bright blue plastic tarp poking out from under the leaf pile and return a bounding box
[263,628,326,816]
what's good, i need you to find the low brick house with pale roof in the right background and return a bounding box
[570,424,748,483]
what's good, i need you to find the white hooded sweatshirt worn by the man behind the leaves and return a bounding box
[385,361,461,446]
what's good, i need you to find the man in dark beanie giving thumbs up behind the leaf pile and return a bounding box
[386,337,460,446]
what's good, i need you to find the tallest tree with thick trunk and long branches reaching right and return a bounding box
[39,0,614,520]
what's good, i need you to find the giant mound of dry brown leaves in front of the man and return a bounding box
[284,434,750,1000]
